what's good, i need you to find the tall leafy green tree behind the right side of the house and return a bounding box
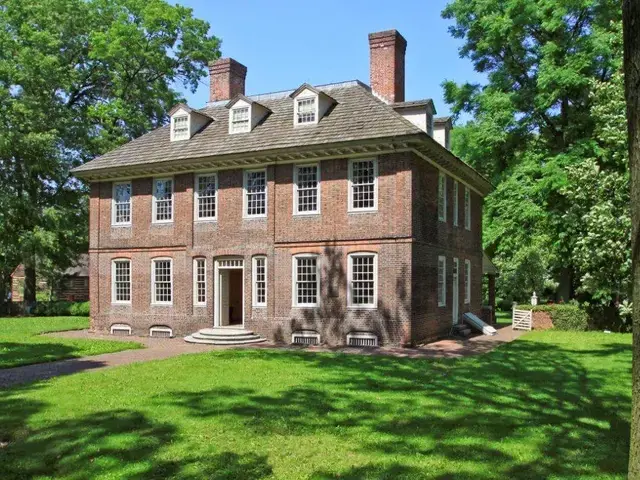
[443,0,624,300]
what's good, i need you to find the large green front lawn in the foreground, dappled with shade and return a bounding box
[0,331,631,480]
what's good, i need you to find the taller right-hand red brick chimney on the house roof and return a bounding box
[369,30,407,103]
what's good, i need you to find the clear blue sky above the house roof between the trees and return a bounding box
[172,0,482,115]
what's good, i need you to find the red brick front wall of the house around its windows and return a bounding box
[90,153,481,344]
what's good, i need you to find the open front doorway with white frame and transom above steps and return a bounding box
[213,258,244,327]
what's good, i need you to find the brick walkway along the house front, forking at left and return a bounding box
[0,326,525,388]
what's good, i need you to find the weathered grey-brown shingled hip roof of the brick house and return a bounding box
[72,81,491,195]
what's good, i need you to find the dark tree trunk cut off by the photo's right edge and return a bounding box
[622,0,640,480]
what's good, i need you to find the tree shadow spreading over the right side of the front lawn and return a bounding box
[162,341,631,479]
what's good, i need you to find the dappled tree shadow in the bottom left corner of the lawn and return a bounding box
[0,384,272,480]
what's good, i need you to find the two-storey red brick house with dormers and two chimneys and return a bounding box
[74,30,491,345]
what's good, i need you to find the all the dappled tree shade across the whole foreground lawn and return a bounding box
[0,341,631,479]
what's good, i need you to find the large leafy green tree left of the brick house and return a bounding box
[0,0,219,308]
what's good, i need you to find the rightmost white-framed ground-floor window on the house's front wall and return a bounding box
[347,253,378,308]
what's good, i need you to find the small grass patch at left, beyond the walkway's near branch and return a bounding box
[0,317,141,369]
